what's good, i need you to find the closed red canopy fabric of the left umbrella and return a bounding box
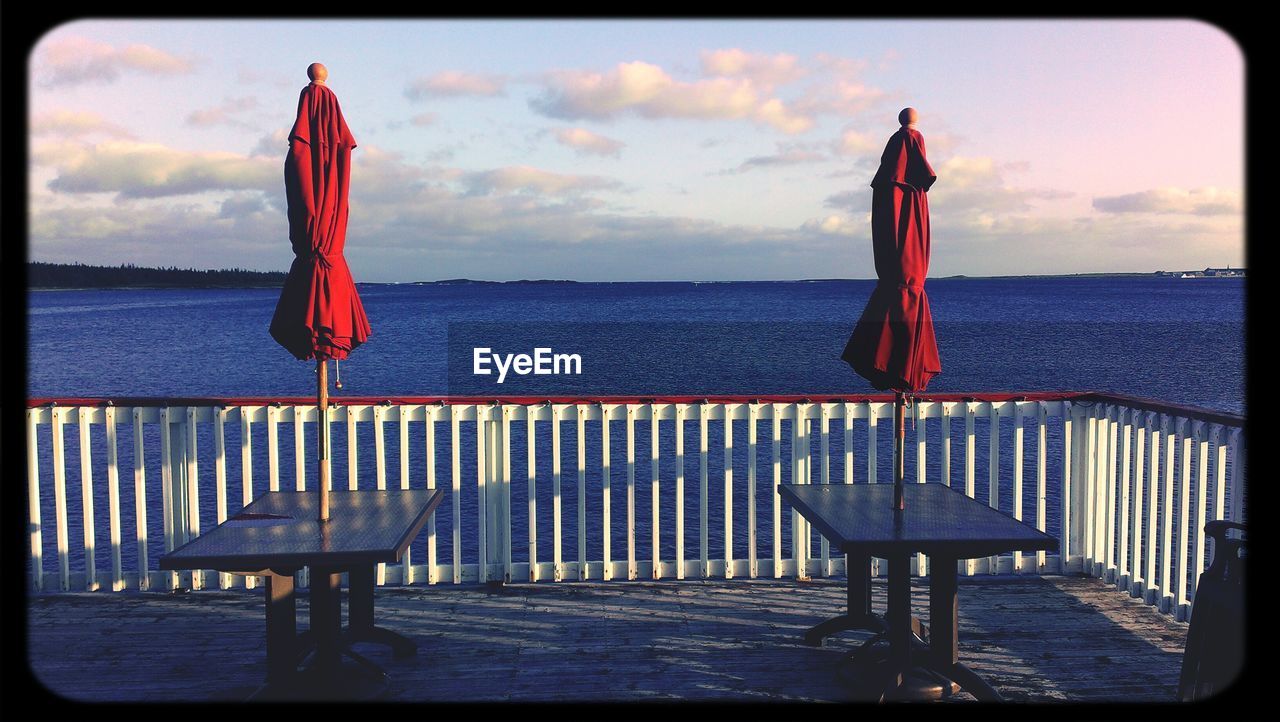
[270,82,372,361]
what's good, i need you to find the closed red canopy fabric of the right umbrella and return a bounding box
[841,125,942,393]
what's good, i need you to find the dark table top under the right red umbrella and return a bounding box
[778,483,1057,559]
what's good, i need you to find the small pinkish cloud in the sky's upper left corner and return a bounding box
[33,36,192,87]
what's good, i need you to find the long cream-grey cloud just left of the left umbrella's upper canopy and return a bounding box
[32,141,282,198]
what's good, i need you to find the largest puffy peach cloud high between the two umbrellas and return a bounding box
[530,61,813,133]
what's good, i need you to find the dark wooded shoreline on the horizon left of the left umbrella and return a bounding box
[27,262,285,288]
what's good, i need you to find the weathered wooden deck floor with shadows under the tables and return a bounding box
[27,577,1187,702]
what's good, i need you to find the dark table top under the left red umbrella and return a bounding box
[160,489,444,574]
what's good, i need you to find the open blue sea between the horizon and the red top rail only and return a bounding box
[27,277,1244,412]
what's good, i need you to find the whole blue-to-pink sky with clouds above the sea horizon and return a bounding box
[28,19,1245,282]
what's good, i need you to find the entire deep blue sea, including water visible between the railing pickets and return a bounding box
[27,275,1245,575]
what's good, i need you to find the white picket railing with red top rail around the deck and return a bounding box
[27,393,1244,618]
